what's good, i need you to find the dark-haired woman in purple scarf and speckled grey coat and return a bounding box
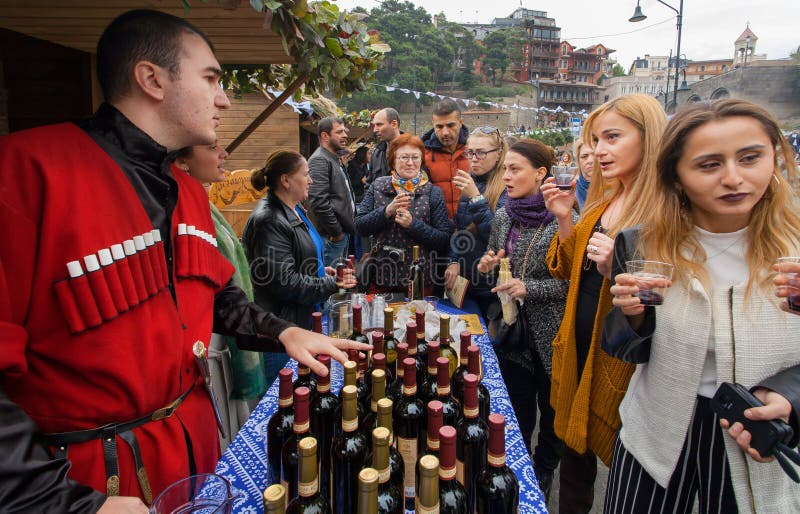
[478,139,569,499]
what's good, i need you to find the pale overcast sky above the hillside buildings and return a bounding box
[336,0,800,69]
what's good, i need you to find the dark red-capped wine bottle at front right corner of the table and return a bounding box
[475,414,519,514]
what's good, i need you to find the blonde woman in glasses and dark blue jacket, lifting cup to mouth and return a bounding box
[444,127,508,317]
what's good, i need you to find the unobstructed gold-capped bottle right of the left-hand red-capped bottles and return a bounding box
[330,385,367,514]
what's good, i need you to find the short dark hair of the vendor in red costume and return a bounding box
[97,9,214,101]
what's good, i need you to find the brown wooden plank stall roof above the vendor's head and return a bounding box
[0,0,292,64]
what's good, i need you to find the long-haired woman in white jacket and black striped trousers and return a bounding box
[603,99,800,513]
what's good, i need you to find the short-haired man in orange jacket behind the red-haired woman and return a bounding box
[422,100,469,219]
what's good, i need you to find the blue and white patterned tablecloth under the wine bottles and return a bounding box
[216,304,547,514]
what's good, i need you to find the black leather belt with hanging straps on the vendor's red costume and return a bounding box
[42,386,194,504]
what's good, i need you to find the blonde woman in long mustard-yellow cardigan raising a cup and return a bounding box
[542,95,667,513]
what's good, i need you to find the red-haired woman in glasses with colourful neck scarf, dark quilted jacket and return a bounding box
[356,134,453,295]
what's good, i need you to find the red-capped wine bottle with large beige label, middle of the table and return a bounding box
[393,357,424,510]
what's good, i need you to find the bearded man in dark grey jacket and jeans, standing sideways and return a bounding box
[308,117,356,266]
